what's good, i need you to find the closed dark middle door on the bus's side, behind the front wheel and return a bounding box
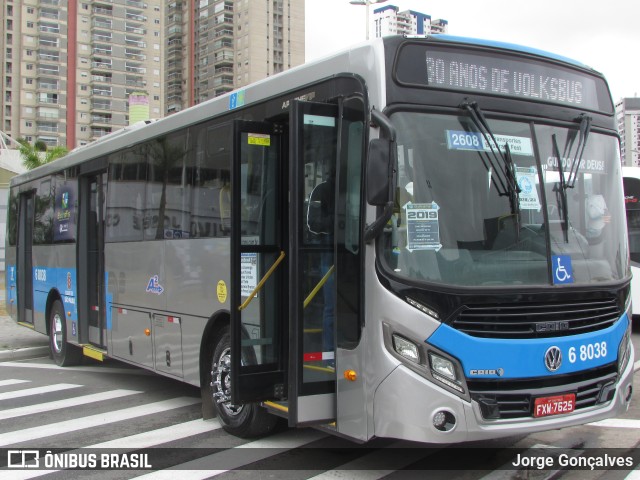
[78,172,106,347]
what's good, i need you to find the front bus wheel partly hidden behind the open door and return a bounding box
[209,326,278,438]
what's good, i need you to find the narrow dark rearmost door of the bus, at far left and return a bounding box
[17,192,34,323]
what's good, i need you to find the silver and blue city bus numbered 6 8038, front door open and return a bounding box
[6,35,634,443]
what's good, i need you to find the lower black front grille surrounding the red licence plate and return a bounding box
[467,364,618,420]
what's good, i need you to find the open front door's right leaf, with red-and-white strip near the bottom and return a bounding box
[289,101,339,426]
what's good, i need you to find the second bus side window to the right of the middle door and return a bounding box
[144,130,191,240]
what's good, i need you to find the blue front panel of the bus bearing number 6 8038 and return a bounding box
[426,314,629,379]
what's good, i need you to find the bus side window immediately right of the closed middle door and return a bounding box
[105,145,147,242]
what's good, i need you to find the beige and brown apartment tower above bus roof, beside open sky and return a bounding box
[175,0,305,113]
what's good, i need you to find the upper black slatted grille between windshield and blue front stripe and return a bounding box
[451,297,622,338]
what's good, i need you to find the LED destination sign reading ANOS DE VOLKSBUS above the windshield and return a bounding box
[396,44,611,112]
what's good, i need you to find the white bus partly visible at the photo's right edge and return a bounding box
[622,167,640,318]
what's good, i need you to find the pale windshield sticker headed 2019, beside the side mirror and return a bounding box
[403,202,442,252]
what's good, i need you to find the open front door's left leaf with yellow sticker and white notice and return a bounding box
[231,121,288,404]
